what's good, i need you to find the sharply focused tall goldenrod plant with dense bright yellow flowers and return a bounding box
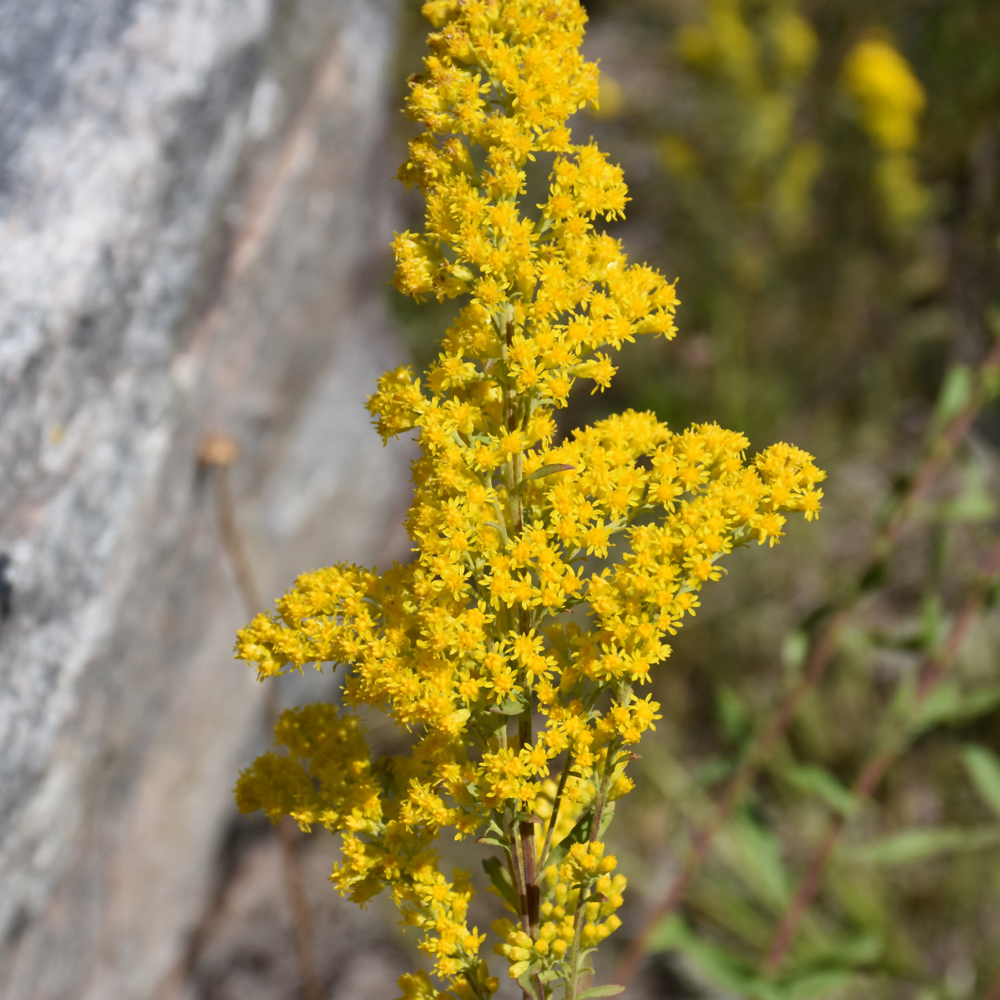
[236,0,824,1000]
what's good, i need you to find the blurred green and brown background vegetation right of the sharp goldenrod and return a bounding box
[394,0,1000,1000]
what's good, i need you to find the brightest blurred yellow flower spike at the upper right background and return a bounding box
[843,38,929,225]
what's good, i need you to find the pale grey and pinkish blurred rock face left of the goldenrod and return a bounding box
[0,0,406,1000]
